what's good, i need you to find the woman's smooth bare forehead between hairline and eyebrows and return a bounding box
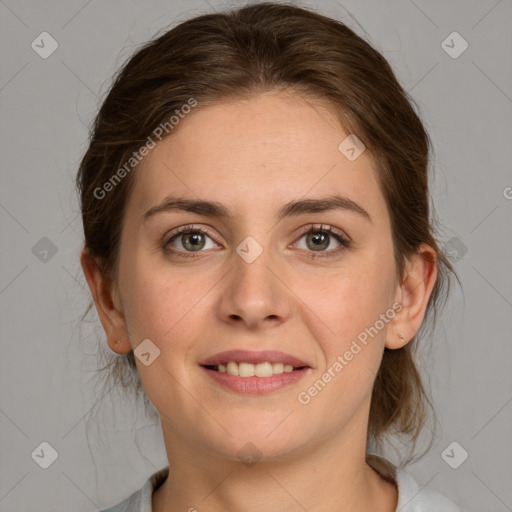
[126,92,385,222]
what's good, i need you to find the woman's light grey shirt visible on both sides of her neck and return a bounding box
[100,455,462,512]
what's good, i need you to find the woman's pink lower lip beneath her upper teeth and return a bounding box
[201,366,310,395]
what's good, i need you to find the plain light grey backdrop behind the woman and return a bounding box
[0,0,512,512]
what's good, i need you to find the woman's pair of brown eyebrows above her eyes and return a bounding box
[142,195,372,223]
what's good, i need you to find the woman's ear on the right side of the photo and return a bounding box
[386,244,437,349]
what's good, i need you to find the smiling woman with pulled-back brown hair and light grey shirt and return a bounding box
[77,3,459,512]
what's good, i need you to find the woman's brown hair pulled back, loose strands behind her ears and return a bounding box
[76,3,453,460]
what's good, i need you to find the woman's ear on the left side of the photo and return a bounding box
[80,248,131,354]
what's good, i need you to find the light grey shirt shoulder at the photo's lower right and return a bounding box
[396,468,462,512]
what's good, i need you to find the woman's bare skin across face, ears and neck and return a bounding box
[81,91,437,512]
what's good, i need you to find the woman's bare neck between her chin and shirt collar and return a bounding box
[153,418,398,512]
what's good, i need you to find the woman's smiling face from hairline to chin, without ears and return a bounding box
[111,93,401,459]
